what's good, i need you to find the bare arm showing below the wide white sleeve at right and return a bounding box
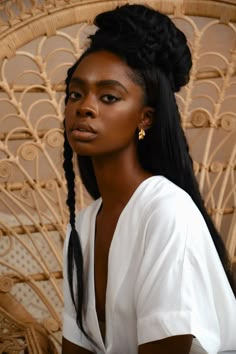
[138,334,193,354]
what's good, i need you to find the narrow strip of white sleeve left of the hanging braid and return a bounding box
[62,226,92,350]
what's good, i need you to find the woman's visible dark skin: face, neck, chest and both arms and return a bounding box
[62,51,192,354]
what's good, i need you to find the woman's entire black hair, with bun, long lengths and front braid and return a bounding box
[64,5,235,335]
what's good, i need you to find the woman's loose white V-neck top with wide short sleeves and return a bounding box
[63,176,236,354]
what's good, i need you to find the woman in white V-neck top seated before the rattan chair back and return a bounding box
[63,5,236,354]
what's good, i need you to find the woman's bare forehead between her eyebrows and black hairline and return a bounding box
[72,51,137,86]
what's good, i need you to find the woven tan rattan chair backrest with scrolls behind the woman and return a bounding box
[0,0,236,353]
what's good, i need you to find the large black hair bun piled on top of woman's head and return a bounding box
[91,5,192,91]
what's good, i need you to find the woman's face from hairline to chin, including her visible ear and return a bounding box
[65,51,148,157]
